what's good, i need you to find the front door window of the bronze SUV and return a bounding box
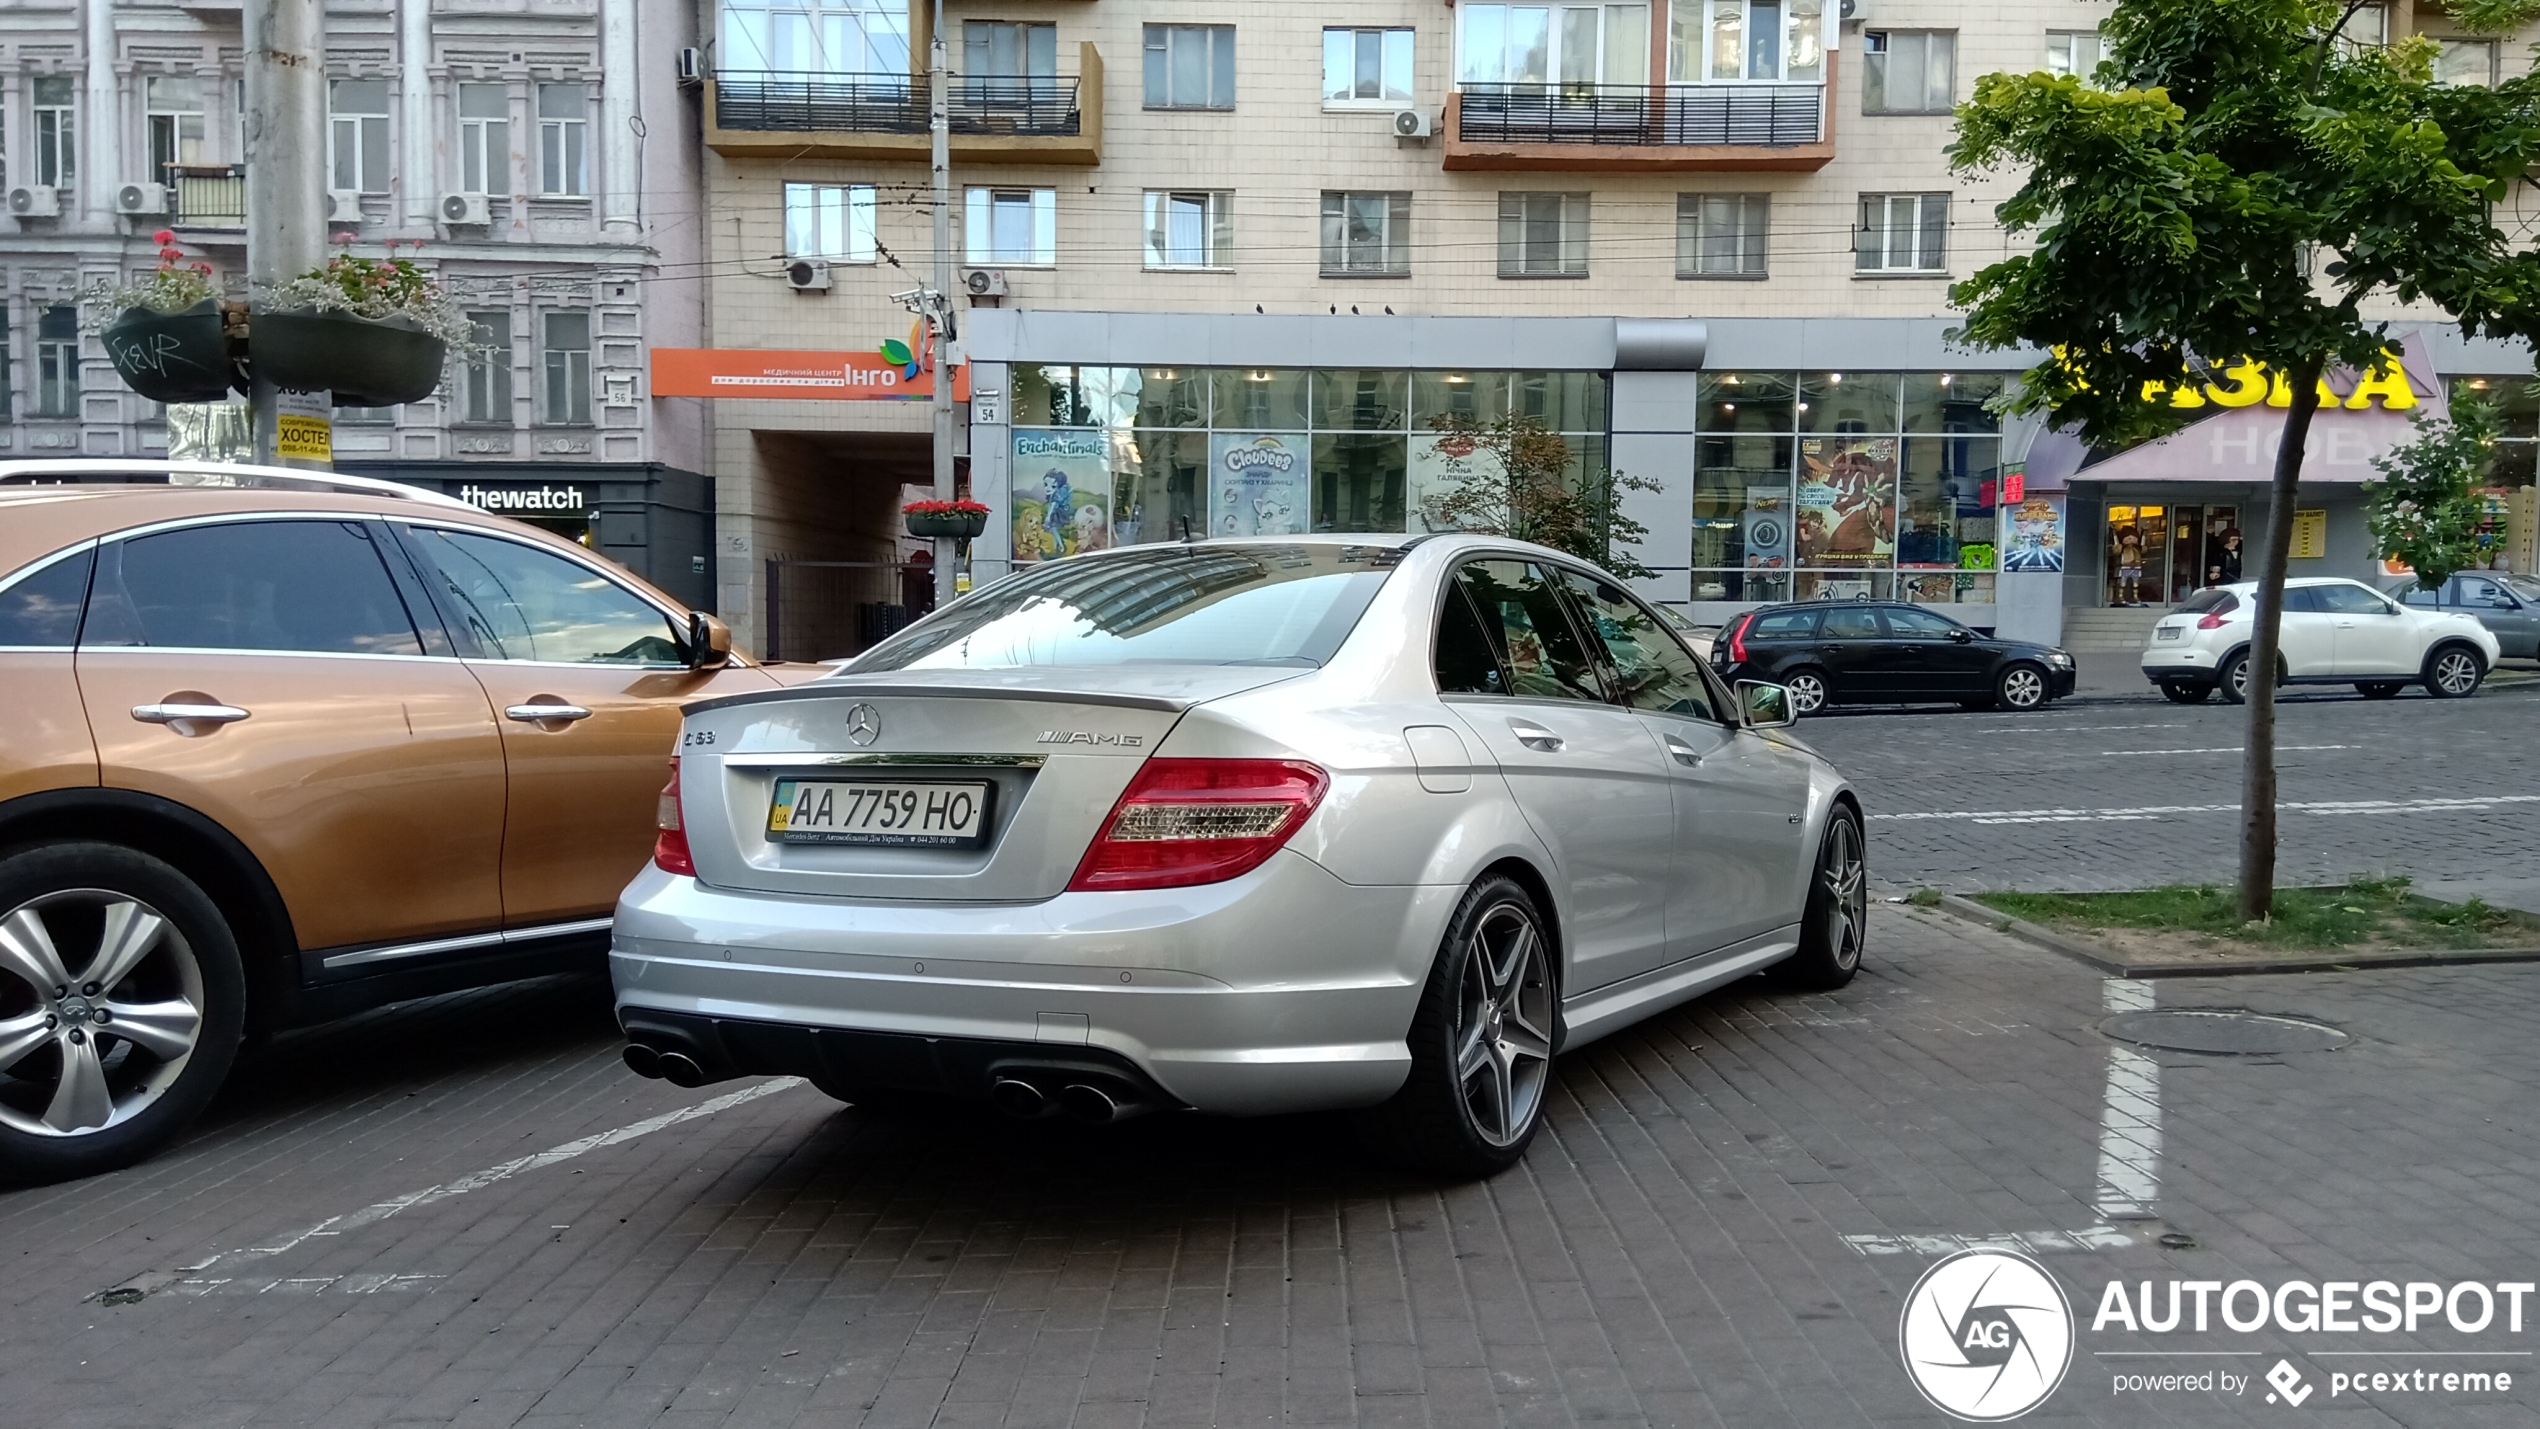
[409,525,688,665]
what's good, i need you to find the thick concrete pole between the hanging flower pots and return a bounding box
[241,0,330,470]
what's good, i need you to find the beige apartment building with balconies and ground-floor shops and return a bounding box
[701,0,2540,655]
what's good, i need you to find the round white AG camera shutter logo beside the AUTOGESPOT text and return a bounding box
[1897,1251,2073,1424]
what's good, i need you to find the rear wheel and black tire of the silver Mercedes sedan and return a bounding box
[1364,876,1562,1180]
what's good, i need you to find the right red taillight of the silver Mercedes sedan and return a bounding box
[1067,759,1331,893]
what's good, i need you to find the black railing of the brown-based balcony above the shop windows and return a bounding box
[1455,84,1826,147]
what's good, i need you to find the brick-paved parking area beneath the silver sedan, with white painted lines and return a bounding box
[0,909,2540,1429]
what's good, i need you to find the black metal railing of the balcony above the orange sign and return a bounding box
[714,71,1085,135]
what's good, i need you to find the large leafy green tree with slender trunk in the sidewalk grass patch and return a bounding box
[1948,0,2540,919]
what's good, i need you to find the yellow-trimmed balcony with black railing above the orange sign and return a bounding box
[706,43,1102,165]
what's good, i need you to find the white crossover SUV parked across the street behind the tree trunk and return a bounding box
[2144,579,2497,706]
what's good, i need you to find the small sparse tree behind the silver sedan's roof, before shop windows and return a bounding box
[1420,411,1659,579]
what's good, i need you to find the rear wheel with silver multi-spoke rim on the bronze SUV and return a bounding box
[0,843,246,1183]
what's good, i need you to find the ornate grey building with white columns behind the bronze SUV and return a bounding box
[0,0,714,604]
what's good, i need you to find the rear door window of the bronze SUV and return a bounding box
[81,520,424,655]
